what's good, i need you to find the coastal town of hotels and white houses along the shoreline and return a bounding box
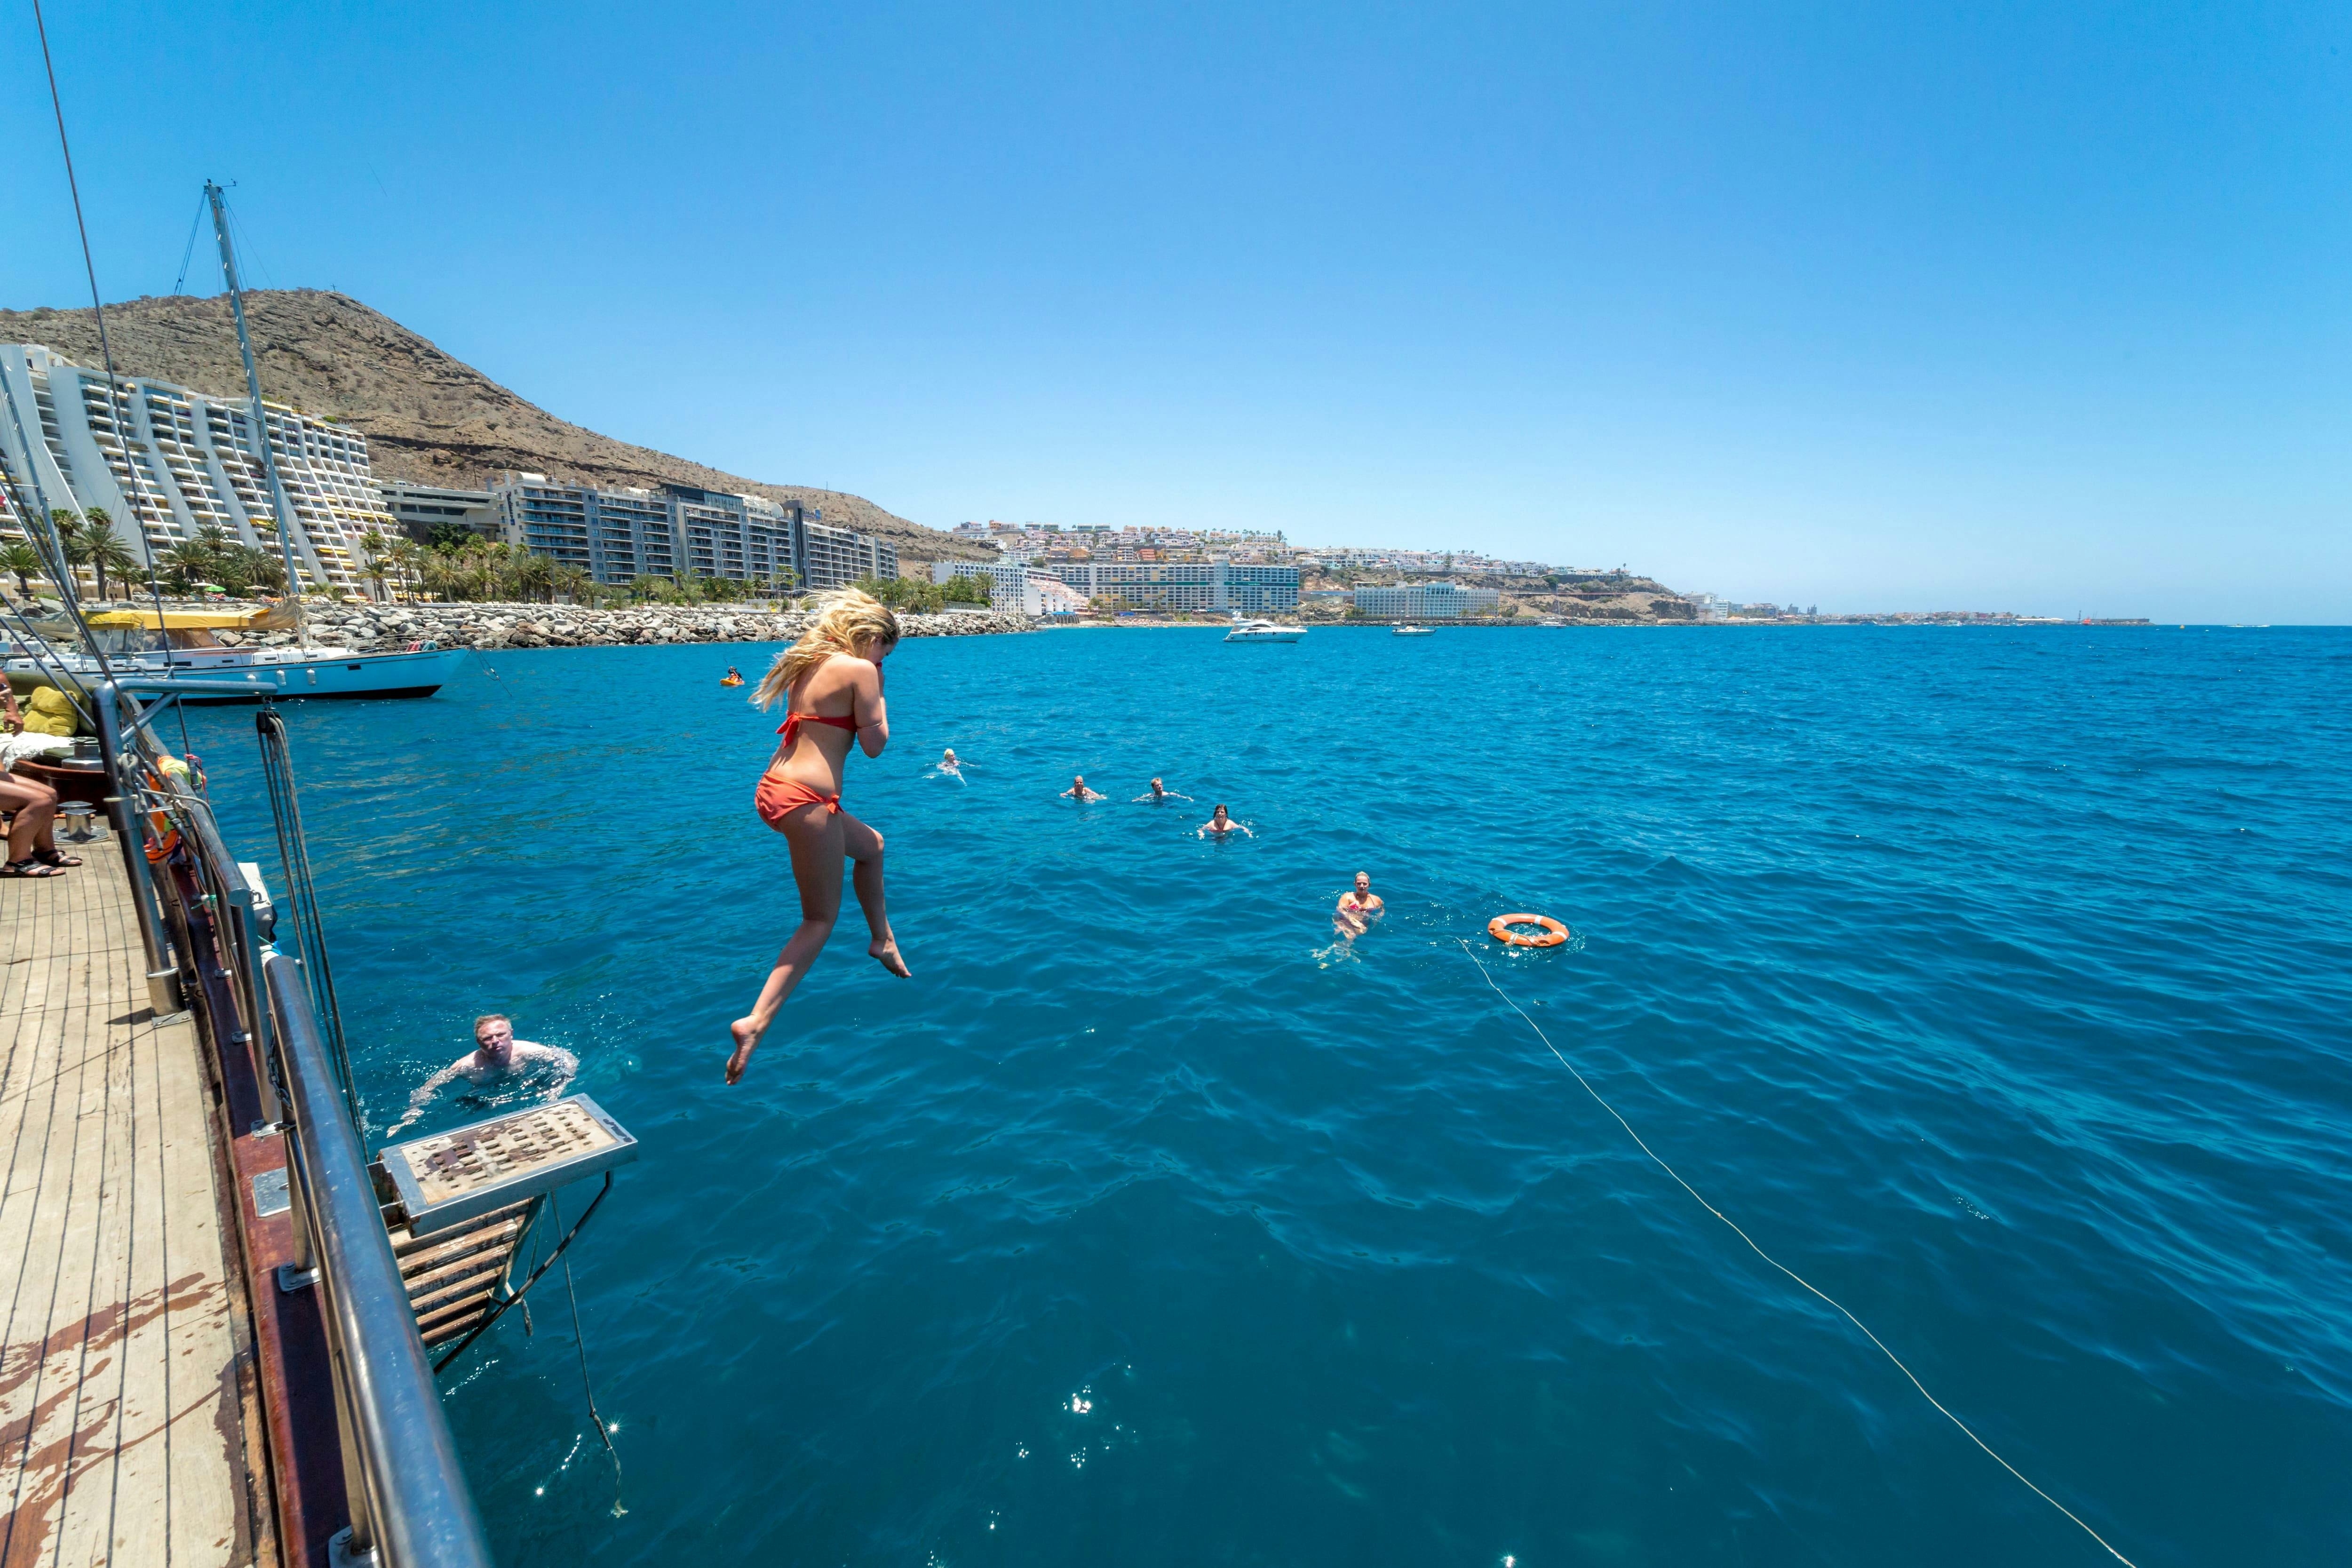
[0,331,2136,630]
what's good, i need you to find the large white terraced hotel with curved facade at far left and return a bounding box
[0,343,393,590]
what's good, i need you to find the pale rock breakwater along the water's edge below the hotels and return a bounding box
[219,604,1035,651]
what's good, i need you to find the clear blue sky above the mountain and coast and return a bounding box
[0,0,2352,621]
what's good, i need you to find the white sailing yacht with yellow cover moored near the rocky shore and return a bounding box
[7,609,466,703]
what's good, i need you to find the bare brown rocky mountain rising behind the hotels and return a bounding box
[0,289,988,562]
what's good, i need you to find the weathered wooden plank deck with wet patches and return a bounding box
[0,837,275,1568]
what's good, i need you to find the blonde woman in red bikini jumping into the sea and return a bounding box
[727,588,908,1084]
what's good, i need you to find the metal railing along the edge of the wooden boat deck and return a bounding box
[86,670,492,1568]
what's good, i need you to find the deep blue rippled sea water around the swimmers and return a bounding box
[195,628,2352,1568]
